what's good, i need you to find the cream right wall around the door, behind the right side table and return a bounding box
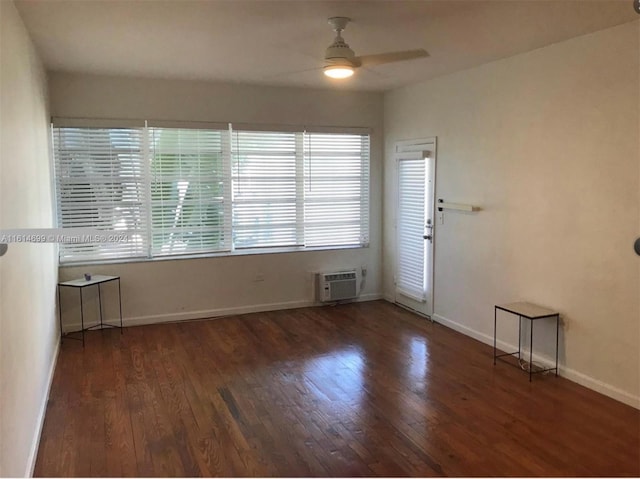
[383,21,640,407]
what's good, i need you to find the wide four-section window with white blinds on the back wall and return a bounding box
[53,122,369,263]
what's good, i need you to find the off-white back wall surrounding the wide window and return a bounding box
[49,73,383,330]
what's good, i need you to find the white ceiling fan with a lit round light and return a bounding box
[324,17,429,78]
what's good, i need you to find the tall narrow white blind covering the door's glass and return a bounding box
[396,159,426,301]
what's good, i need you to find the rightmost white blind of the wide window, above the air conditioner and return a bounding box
[304,133,369,247]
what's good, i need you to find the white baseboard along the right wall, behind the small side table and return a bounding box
[433,314,640,409]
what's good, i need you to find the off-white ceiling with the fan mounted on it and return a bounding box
[12,0,638,90]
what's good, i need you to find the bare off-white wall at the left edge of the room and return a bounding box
[0,1,58,476]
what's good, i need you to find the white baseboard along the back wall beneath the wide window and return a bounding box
[64,293,382,331]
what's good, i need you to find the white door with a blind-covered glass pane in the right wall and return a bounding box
[395,139,436,316]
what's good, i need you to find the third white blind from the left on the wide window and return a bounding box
[231,131,303,249]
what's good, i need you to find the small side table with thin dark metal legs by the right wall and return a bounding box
[493,302,560,381]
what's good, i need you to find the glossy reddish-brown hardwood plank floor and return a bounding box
[35,301,640,476]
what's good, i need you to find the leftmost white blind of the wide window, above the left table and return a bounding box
[53,128,147,262]
